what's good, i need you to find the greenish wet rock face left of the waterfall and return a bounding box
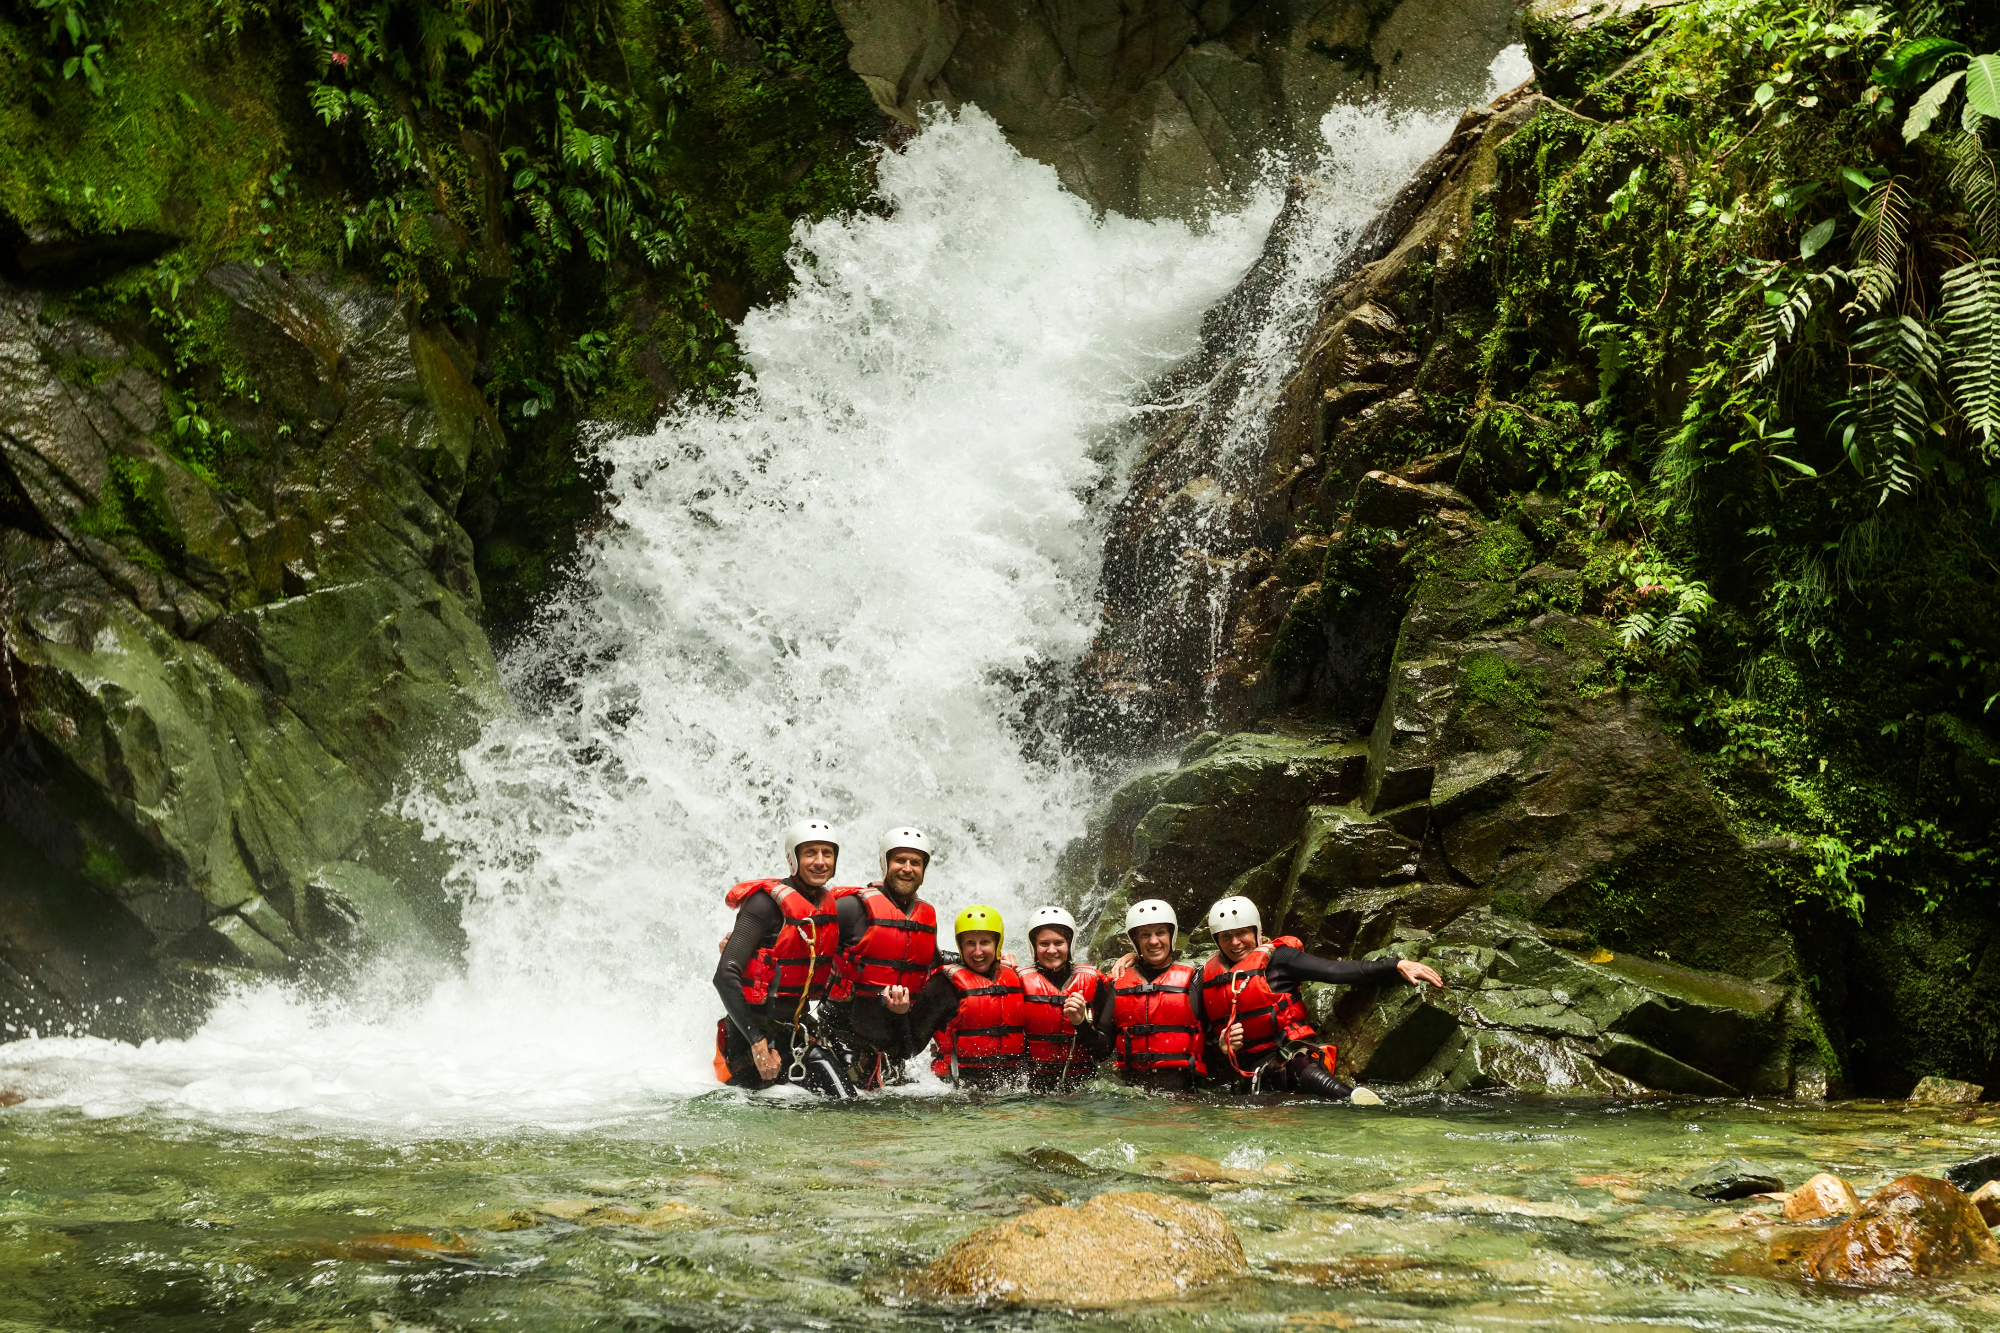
[0,264,500,1035]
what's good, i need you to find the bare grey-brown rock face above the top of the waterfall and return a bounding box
[834,0,1518,216]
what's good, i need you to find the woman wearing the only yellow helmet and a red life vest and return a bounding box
[910,903,1028,1087]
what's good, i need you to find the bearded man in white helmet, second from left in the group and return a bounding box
[822,829,938,1089]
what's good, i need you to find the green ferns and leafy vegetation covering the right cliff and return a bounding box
[1328,0,2000,1087]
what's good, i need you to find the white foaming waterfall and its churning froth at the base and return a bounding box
[0,78,1512,1129]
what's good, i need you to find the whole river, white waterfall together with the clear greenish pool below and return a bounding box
[0,52,2000,1331]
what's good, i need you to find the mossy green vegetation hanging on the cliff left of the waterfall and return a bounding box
[0,0,880,628]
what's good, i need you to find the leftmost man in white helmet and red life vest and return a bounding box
[716,819,852,1095]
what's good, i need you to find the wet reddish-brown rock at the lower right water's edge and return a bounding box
[1802,1175,2000,1287]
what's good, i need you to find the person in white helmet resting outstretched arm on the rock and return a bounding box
[1194,897,1444,1101]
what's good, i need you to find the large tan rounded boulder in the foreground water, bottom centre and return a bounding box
[926,1193,1244,1309]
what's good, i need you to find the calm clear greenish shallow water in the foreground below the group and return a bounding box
[0,1091,2000,1331]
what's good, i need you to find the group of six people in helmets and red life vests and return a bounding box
[716,819,1444,1099]
